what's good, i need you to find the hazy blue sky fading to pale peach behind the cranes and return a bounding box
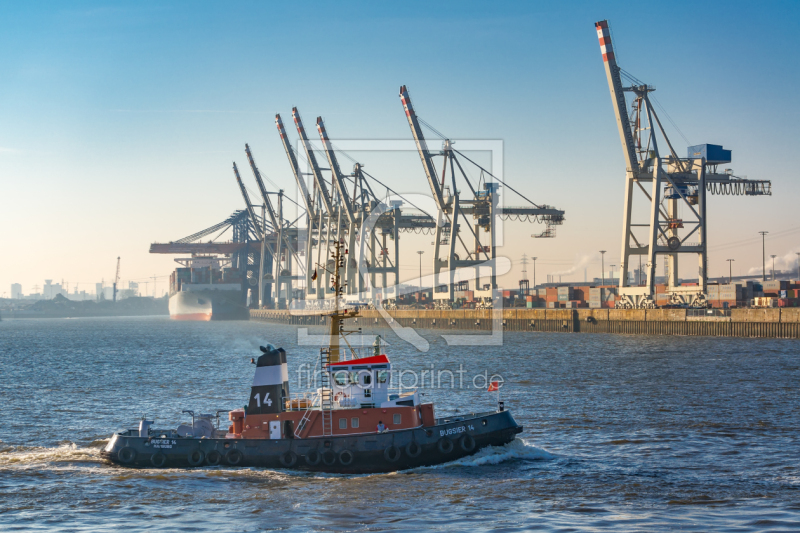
[0,1,800,295]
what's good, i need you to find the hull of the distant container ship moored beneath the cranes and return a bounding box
[169,288,250,321]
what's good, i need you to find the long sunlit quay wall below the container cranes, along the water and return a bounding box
[250,308,800,339]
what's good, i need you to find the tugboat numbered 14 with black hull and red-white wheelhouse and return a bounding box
[103,239,523,474]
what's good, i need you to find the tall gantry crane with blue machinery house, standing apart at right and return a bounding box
[595,20,772,308]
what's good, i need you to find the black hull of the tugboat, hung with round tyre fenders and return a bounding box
[102,411,522,474]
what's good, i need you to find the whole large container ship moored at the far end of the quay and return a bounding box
[169,256,249,321]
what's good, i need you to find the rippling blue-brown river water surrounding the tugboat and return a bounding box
[0,317,800,531]
